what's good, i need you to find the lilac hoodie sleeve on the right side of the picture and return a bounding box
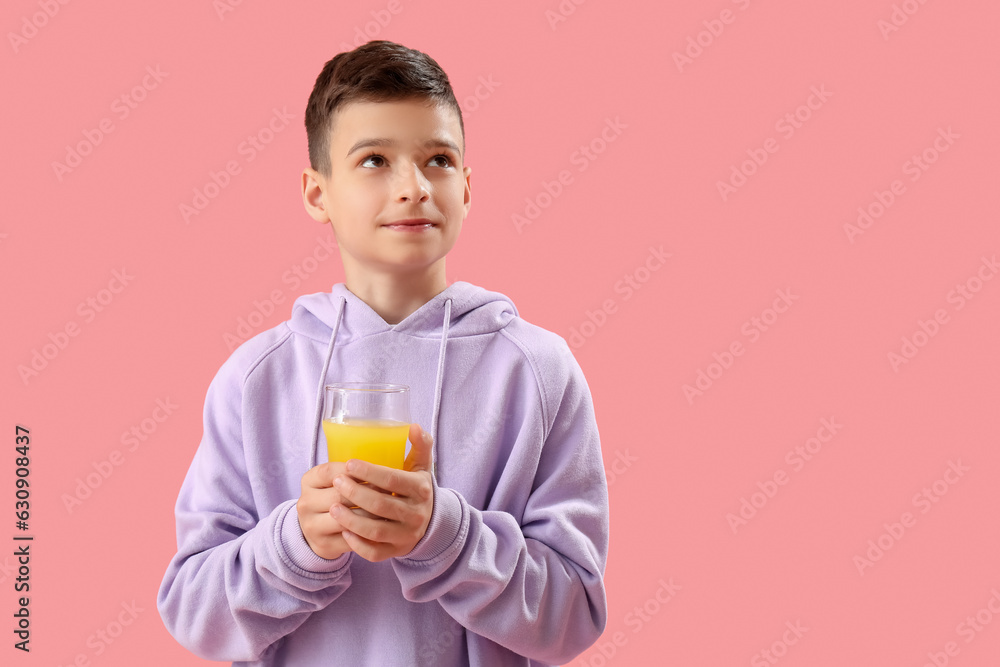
[393,339,608,664]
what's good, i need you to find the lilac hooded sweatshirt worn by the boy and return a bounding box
[157,282,608,667]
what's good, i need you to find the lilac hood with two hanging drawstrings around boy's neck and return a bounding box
[288,281,518,470]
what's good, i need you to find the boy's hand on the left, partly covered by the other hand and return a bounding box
[295,463,351,560]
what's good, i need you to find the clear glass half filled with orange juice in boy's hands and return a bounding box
[323,382,410,470]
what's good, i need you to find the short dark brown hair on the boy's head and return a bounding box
[306,40,465,176]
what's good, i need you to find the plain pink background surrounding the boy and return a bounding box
[0,0,1000,667]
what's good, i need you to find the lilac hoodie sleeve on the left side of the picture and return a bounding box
[157,344,351,661]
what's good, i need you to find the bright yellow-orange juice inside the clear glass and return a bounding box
[323,419,410,470]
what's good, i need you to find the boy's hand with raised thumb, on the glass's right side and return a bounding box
[330,424,434,563]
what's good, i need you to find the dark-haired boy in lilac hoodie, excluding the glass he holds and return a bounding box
[158,41,608,667]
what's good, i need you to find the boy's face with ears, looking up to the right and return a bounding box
[303,99,472,278]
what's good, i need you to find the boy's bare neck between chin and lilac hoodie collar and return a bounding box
[344,262,448,325]
